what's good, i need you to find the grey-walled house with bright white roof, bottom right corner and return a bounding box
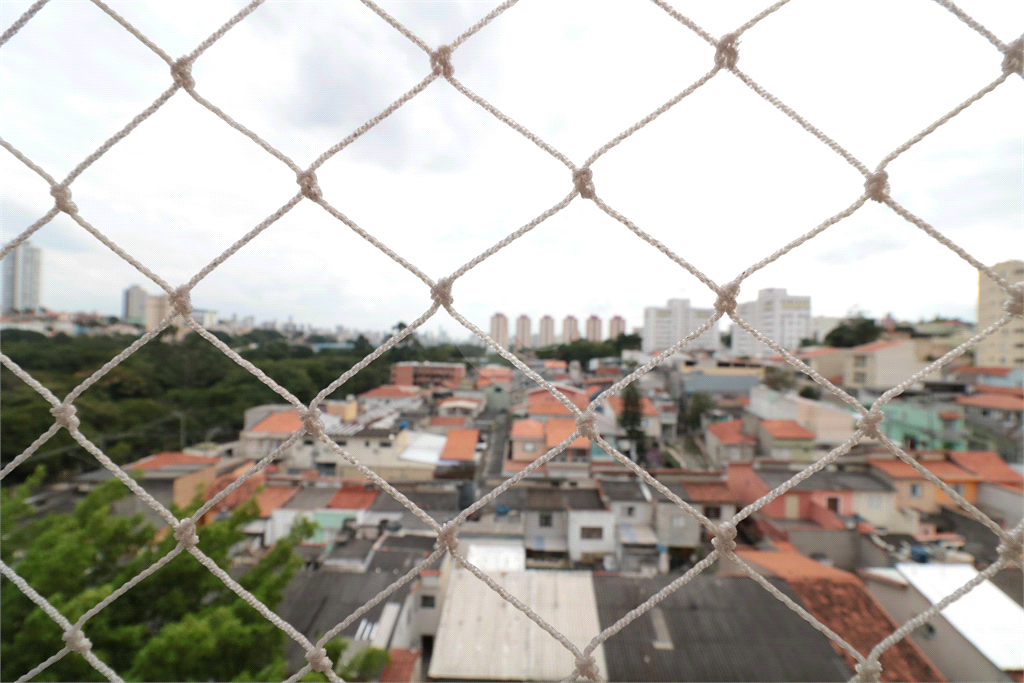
[861,563,1024,681]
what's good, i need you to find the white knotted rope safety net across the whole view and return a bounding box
[0,0,1024,682]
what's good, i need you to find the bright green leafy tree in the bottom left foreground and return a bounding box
[0,468,312,681]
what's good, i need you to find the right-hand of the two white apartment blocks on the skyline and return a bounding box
[732,289,812,356]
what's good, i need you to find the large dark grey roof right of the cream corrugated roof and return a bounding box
[594,575,853,681]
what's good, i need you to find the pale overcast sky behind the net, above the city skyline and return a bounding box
[0,0,1024,337]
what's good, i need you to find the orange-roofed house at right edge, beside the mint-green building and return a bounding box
[956,387,1024,463]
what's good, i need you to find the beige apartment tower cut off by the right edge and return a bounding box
[974,260,1024,368]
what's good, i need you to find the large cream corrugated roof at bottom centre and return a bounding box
[429,569,607,681]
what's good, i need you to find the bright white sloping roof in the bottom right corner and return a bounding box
[896,563,1024,671]
